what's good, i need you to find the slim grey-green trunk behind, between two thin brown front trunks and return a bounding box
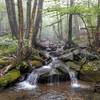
[26,0,32,38]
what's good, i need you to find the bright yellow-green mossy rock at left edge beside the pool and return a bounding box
[0,69,20,86]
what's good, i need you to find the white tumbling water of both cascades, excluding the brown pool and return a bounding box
[18,54,80,90]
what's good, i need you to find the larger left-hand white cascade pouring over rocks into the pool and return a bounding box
[18,57,58,90]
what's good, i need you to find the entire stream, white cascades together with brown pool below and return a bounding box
[0,46,100,100]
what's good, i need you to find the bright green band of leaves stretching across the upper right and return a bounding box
[45,5,100,16]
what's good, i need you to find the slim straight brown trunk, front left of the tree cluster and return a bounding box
[18,0,24,56]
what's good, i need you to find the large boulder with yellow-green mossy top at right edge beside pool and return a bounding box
[79,61,100,83]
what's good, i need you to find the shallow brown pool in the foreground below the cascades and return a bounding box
[0,81,97,100]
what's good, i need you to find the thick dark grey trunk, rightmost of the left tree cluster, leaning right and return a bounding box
[32,0,44,46]
